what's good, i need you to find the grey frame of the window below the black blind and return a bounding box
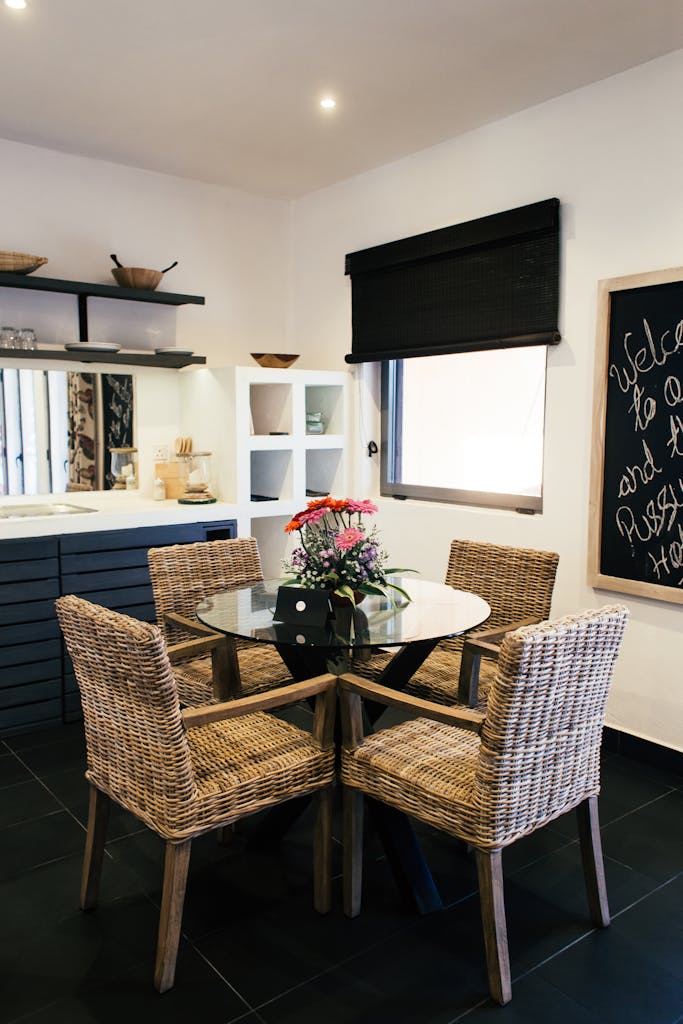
[380,359,548,514]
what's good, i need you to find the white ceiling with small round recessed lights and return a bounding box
[0,0,683,197]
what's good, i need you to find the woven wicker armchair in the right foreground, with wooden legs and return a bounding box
[339,605,628,1004]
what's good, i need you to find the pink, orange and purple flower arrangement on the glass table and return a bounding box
[283,498,412,604]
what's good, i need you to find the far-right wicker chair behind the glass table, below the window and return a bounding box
[401,541,559,710]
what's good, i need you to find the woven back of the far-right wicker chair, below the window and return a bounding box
[445,540,559,651]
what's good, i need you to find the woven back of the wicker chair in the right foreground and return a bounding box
[473,605,628,848]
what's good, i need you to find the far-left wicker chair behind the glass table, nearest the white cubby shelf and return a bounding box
[147,537,292,708]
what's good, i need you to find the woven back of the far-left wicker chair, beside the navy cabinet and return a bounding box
[147,537,263,643]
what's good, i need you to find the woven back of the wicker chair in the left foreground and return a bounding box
[56,596,197,835]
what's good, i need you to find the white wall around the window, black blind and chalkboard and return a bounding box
[288,51,683,749]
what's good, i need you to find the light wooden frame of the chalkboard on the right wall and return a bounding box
[588,266,683,604]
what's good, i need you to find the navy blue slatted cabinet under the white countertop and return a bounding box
[0,519,237,735]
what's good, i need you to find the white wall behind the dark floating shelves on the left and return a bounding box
[0,139,288,366]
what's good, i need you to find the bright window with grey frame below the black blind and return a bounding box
[381,346,546,511]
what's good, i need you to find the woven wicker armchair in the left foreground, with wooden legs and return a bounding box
[56,596,336,992]
